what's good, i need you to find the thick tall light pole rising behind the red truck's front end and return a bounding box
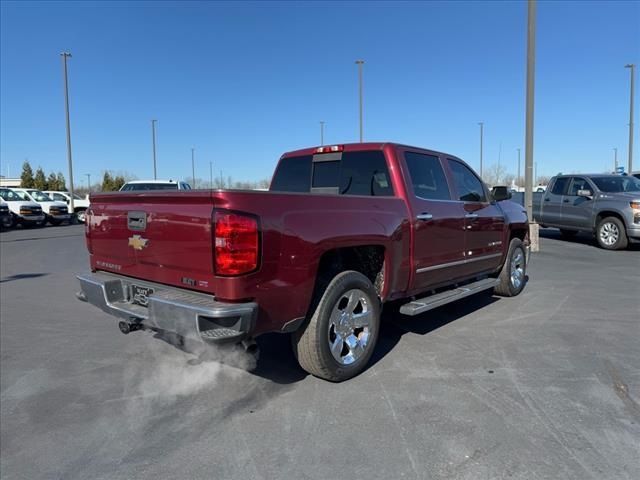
[524,0,540,252]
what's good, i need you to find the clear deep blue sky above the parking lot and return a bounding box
[0,1,640,184]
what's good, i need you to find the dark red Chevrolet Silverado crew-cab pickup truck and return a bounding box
[78,143,529,381]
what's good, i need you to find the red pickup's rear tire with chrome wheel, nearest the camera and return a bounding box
[291,271,380,382]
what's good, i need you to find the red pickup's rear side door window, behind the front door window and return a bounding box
[404,152,451,200]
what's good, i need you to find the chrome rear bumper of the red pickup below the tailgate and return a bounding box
[77,272,258,343]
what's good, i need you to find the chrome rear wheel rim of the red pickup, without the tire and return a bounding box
[329,289,374,365]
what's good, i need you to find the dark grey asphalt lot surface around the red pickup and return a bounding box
[0,226,640,480]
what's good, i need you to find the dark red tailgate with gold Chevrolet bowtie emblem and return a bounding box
[86,192,213,293]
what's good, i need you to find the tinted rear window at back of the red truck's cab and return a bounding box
[270,150,393,196]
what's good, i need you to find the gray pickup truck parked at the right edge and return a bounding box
[533,174,640,250]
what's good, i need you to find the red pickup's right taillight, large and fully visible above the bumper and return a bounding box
[214,212,259,276]
